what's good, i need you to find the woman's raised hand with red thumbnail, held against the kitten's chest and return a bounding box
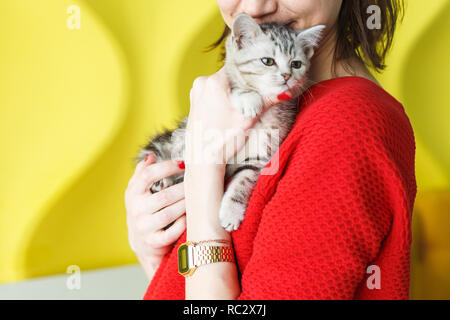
[186,68,292,165]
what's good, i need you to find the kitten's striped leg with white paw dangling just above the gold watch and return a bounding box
[219,165,260,232]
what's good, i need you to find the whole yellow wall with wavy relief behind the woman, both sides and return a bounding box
[0,0,450,298]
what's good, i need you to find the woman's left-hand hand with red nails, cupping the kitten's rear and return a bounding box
[125,154,186,279]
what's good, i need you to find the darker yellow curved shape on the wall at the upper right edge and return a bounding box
[402,2,450,188]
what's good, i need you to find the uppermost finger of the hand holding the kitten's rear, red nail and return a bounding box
[130,160,184,194]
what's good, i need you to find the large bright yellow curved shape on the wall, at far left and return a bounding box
[0,0,127,282]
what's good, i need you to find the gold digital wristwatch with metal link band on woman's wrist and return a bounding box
[178,240,235,277]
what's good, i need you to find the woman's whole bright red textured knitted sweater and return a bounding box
[144,77,417,299]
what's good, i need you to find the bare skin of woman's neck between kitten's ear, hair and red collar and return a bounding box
[309,27,380,85]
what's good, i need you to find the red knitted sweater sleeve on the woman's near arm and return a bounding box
[238,96,396,299]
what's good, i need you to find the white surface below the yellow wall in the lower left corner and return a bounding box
[0,265,149,300]
